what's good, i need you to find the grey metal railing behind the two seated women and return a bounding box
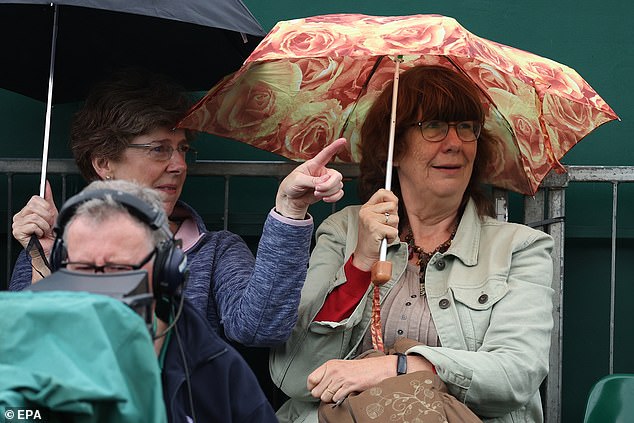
[0,159,634,423]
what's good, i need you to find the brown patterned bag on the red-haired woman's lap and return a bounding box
[318,338,482,423]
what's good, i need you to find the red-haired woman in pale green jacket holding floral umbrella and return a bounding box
[270,66,553,422]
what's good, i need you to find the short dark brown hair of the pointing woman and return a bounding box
[70,68,192,181]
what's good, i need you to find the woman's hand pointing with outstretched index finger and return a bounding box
[275,138,346,219]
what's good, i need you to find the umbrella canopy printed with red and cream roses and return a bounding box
[181,14,618,194]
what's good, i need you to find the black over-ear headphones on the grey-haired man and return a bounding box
[50,189,187,308]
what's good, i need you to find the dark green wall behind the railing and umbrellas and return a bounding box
[0,0,634,423]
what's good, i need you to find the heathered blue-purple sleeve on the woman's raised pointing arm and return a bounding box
[213,214,313,346]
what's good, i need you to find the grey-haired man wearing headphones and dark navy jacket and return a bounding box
[55,180,277,423]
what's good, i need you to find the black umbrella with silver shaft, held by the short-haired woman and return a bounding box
[0,0,265,196]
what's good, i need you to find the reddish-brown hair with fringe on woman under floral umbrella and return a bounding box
[359,66,494,222]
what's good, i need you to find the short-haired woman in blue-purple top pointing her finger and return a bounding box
[10,71,345,346]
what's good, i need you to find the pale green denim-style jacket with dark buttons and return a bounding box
[270,201,553,422]
